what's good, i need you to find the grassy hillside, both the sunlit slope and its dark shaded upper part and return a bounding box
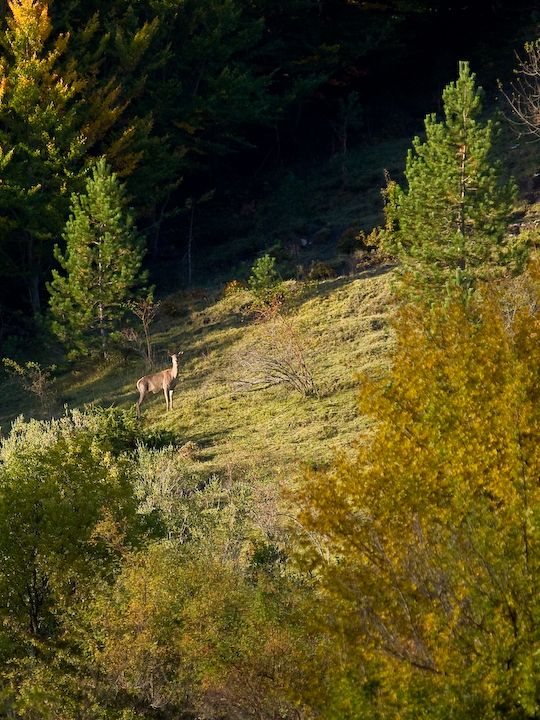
[0,134,400,479]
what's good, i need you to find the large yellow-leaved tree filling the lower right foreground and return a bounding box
[299,271,540,720]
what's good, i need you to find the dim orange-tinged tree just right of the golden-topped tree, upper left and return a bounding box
[51,0,162,208]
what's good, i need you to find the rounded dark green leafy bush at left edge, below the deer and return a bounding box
[0,413,140,654]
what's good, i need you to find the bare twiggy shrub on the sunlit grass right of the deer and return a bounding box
[234,307,318,397]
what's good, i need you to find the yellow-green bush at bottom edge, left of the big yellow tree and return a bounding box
[88,541,305,720]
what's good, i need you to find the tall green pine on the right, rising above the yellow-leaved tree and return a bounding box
[384,62,526,290]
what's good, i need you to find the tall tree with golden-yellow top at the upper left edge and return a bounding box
[0,0,84,315]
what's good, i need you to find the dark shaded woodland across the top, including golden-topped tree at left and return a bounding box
[0,0,534,337]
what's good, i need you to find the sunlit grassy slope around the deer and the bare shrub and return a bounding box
[0,272,390,484]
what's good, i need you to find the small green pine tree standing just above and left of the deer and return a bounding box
[48,158,145,357]
